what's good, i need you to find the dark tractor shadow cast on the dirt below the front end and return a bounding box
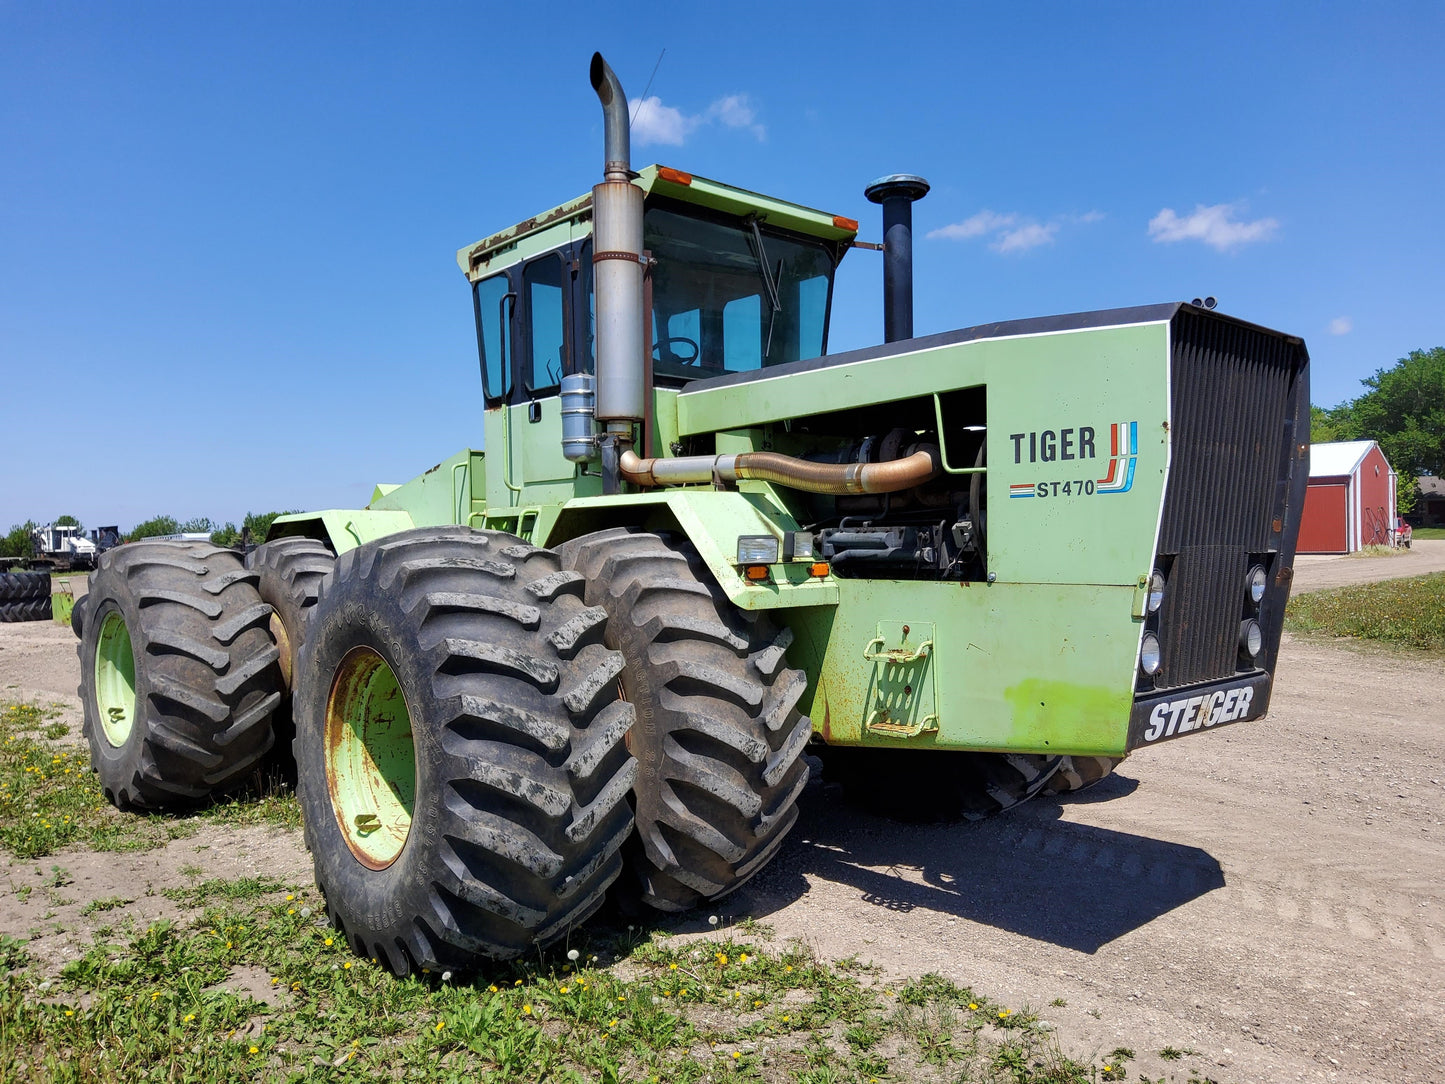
[734,775,1224,952]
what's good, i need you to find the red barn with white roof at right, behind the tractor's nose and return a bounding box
[1299,441,1394,554]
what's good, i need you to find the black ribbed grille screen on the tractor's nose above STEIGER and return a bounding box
[1156,309,1305,688]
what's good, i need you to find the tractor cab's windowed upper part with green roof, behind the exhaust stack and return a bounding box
[457,165,858,415]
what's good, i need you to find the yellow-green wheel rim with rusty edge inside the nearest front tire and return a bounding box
[325,648,416,870]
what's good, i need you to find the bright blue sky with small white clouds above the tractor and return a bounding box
[0,0,1445,529]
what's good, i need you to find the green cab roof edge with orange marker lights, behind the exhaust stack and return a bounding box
[457,165,858,282]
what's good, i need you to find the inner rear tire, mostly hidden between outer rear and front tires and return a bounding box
[246,538,337,783]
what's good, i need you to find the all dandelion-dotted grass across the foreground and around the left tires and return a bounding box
[0,704,1219,1084]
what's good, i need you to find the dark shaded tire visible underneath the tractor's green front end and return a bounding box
[822,747,1064,822]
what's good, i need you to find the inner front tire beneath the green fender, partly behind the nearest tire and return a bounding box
[559,528,812,911]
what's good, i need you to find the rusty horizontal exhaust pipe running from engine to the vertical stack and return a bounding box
[618,444,942,496]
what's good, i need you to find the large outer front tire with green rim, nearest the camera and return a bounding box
[293,528,637,974]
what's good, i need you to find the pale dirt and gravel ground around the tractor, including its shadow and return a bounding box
[0,560,1445,1084]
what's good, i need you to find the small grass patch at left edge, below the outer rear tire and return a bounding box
[0,704,301,859]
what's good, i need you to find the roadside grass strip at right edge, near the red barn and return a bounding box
[1285,572,1445,655]
